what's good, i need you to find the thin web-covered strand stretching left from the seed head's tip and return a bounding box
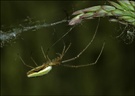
[0,20,68,47]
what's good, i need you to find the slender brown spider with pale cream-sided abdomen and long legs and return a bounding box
[19,18,105,77]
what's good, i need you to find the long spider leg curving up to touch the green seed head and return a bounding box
[61,19,100,63]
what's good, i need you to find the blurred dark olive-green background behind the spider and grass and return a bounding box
[0,1,135,96]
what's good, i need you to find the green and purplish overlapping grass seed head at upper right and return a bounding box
[69,0,135,26]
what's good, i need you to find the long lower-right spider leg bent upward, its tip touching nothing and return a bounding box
[61,42,105,68]
